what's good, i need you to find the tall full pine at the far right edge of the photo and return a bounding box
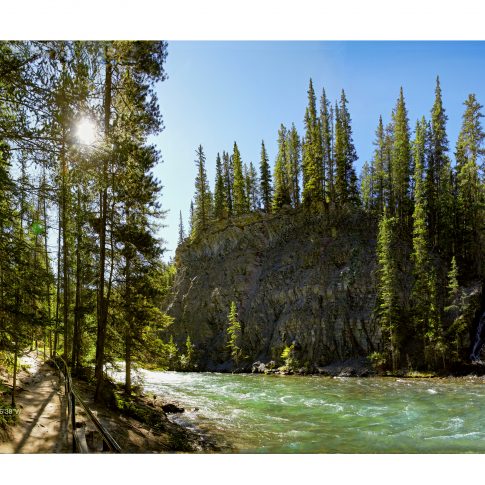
[455,94,485,277]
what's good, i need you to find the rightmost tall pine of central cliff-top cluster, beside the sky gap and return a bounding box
[335,90,359,205]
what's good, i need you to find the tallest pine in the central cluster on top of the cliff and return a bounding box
[300,79,325,206]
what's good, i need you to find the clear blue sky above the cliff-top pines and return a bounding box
[155,41,485,259]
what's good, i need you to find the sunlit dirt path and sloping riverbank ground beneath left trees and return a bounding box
[0,351,220,453]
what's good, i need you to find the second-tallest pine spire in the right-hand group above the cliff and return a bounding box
[391,88,412,223]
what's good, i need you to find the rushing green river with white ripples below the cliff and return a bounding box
[110,370,485,453]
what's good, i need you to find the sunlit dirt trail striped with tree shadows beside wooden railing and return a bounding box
[0,353,70,453]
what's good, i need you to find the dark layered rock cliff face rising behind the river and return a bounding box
[167,209,380,370]
